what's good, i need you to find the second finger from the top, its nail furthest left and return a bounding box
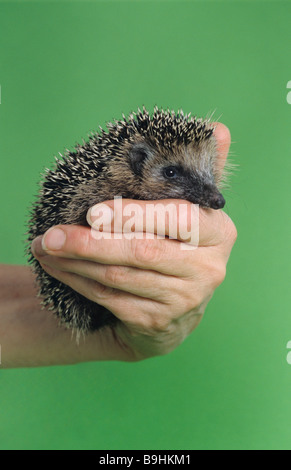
[32,229,191,275]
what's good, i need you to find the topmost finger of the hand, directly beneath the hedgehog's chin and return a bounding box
[87,199,231,248]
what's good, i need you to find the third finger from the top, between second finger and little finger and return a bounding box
[40,256,224,313]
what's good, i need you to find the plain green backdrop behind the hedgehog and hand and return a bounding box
[0,0,291,450]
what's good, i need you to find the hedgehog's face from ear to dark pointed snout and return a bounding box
[129,142,225,209]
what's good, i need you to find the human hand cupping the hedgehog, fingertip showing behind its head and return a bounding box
[33,124,236,360]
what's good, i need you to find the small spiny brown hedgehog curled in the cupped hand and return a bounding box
[26,107,225,335]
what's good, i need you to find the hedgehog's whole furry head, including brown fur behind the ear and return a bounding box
[102,136,225,209]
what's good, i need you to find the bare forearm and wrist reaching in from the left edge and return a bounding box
[0,265,132,369]
